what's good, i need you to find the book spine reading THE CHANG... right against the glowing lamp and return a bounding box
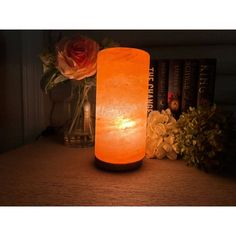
[148,60,157,114]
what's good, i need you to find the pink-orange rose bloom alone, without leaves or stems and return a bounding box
[56,36,99,80]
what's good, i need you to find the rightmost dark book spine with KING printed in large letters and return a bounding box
[197,59,216,107]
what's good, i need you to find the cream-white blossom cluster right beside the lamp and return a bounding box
[146,109,178,160]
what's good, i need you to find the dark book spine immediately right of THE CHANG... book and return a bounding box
[157,60,169,111]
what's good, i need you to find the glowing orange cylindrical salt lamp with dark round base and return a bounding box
[95,47,150,170]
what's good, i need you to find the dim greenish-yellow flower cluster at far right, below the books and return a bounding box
[176,105,232,171]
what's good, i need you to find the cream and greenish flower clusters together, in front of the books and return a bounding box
[146,105,234,171]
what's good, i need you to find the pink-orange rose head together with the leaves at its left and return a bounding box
[40,35,99,93]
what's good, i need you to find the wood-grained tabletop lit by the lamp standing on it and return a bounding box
[0,138,236,206]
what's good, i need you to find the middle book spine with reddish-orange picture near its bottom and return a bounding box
[168,60,183,118]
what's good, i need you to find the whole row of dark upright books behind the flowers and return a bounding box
[148,58,216,118]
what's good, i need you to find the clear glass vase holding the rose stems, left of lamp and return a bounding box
[64,78,95,147]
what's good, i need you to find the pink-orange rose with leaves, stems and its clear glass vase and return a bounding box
[40,35,118,146]
